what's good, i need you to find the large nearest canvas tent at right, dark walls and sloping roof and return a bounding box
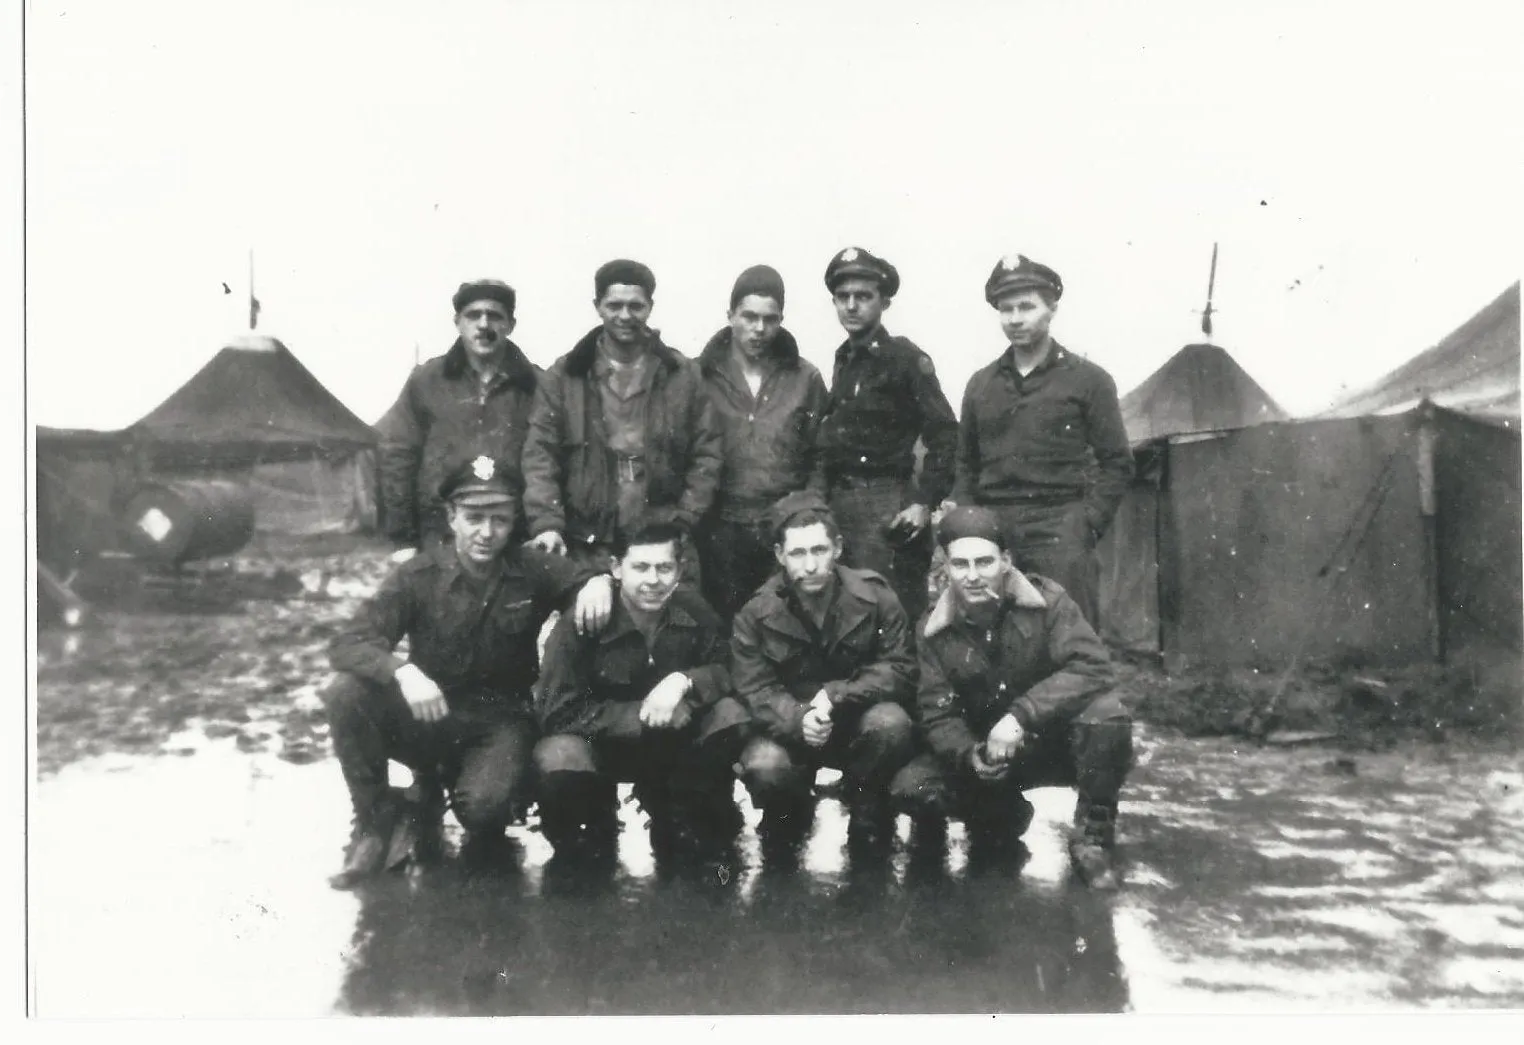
[1102,286,1524,673]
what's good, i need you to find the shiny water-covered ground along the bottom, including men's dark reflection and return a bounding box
[30,728,1524,1016]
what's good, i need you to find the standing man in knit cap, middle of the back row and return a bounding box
[698,265,826,629]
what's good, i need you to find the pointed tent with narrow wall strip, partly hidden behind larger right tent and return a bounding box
[1099,344,1286,652]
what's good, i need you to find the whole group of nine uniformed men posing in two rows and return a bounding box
[325,247,1132,888]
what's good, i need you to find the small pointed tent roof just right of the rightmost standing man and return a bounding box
[1122,344,1288,445]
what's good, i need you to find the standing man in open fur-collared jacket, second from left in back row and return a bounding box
[524,259,724,585]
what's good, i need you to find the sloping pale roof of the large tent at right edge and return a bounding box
[1326,283,1519,430]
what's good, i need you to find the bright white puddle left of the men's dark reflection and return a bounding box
[29,740,358,1018]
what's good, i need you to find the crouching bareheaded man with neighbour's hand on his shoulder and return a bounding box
[535,523,750,858]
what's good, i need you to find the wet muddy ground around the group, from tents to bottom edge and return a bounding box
[29,542,1524,1016]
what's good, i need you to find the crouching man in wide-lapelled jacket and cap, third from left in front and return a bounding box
[730,492,916,861]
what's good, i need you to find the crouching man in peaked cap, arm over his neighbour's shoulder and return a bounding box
[323,457,613,888]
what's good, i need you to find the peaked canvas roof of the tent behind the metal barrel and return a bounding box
[128,335,375,469]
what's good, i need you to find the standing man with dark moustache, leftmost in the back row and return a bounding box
[376,279,539,558]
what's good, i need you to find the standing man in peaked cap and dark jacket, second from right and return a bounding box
[820,247,957,620]
